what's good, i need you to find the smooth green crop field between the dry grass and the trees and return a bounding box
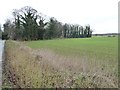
[27,37,118,62]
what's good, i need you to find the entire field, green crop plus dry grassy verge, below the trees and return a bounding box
[2,37,118,88]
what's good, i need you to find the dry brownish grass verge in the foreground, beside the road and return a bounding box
[3,41,118,88]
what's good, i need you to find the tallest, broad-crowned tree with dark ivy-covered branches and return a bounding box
[13,6,46,40]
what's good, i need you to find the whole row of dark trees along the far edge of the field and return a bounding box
[2,6,92,40]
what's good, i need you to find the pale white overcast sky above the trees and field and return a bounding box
[0,0,119,34]
